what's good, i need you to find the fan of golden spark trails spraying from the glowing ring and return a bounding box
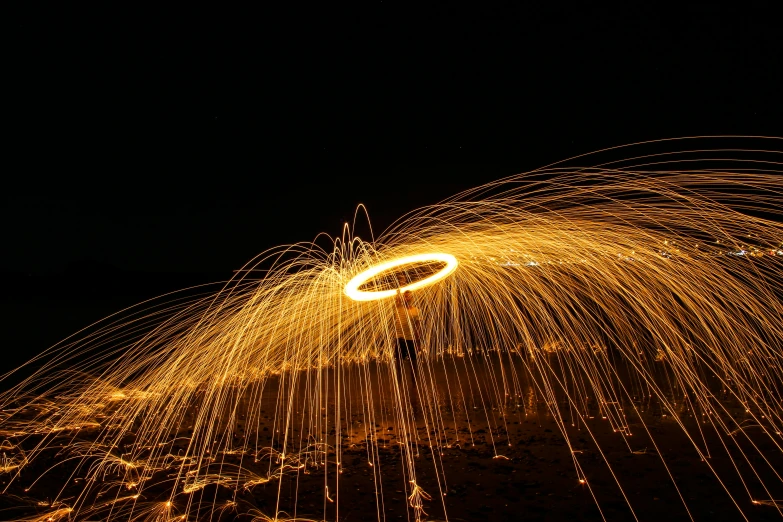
[0,139,783,520]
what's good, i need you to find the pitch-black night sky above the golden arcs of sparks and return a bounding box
[0,7,783,362]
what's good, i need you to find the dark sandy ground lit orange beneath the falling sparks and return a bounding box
[0,356,783,521]
